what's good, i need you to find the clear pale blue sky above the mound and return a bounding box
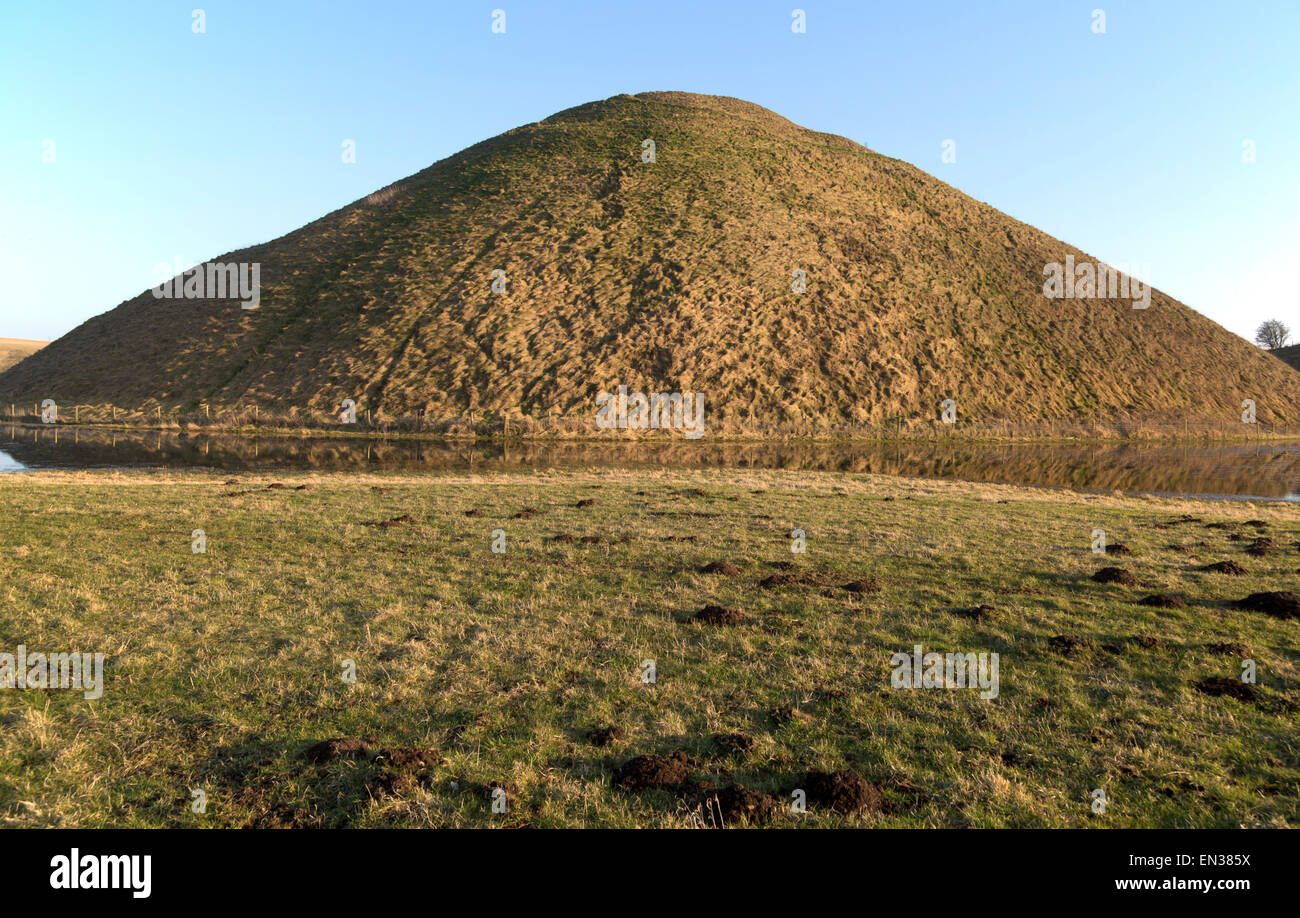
[0,0,1300,338]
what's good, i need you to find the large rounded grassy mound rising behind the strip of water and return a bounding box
[0,92,1300,434]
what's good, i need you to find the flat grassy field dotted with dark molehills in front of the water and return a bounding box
[0,469,1300,827]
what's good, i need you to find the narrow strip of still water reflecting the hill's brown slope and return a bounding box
[0,428,1300,498]
